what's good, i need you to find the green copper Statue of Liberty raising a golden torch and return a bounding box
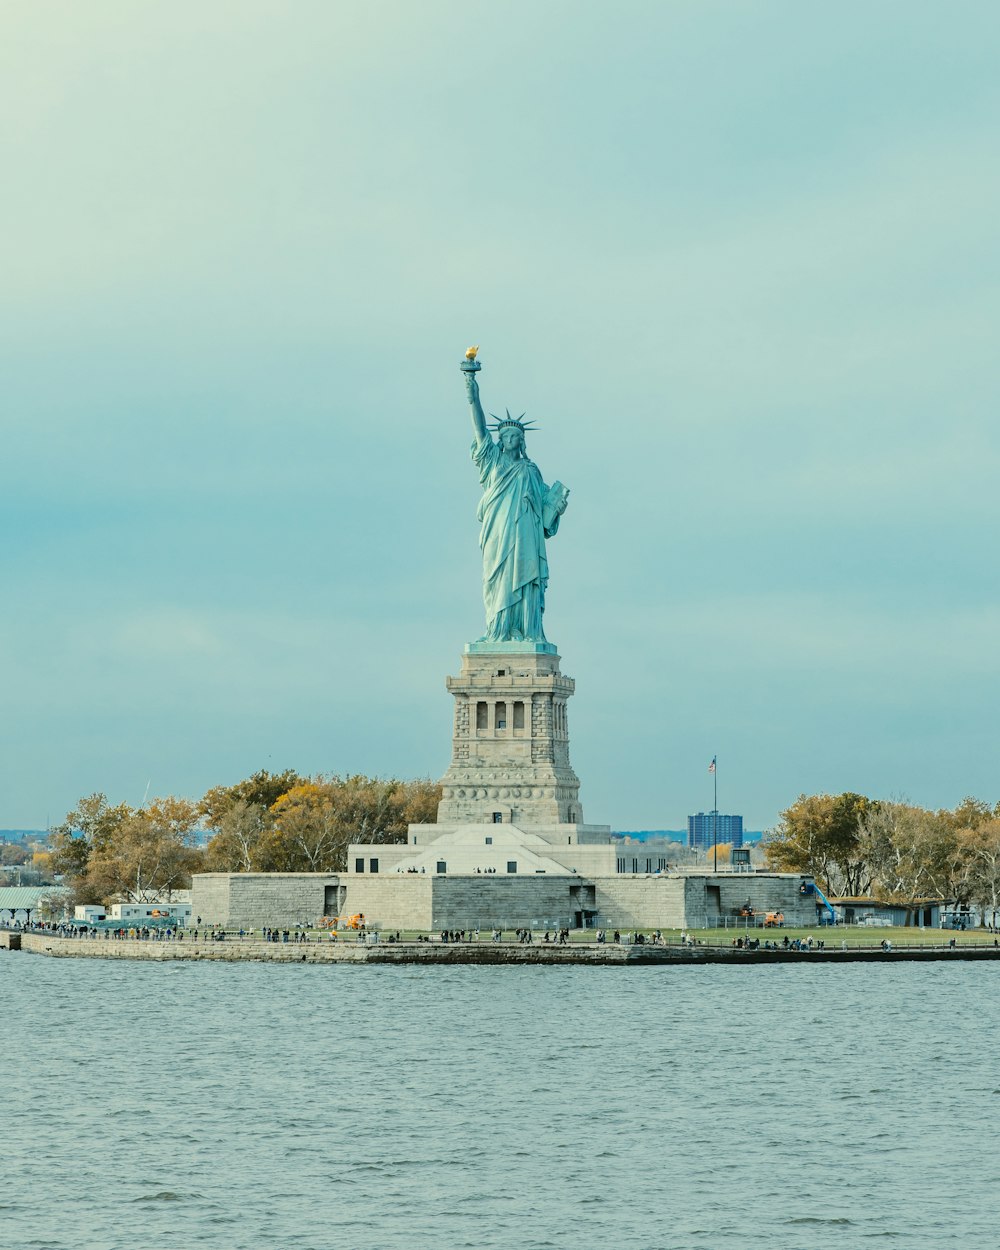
[461,348,569,643]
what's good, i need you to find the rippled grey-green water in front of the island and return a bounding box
[0,954,1000,1250]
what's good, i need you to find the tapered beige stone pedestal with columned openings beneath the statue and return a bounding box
[438,643,584,828]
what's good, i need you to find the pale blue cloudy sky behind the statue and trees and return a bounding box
[0,0,1000,830]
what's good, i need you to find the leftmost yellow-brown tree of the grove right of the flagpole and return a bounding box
[764,793,871,896]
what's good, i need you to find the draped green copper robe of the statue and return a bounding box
[473,438,559,643]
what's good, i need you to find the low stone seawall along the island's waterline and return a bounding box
[7,931,1000,968]
